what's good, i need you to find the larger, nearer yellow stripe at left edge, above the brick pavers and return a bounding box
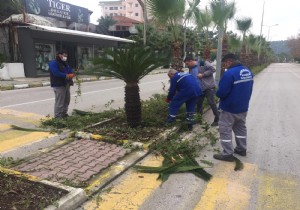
[0,130,53,152]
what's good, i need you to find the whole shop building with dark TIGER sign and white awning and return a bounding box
[0,0,132,77]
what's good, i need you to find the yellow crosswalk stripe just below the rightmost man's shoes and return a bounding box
[195,162,257,210]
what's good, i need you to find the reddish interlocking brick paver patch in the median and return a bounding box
[13,139,126,184]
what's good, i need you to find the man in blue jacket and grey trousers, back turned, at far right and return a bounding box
[214,53,253,162]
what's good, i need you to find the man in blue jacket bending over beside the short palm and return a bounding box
[167,69,201,130]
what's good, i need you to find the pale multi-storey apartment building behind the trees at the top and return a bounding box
[99,0,144,22]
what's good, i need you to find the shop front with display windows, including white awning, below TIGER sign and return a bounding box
[17,24,133,77]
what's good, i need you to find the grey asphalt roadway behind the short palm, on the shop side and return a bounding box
[0,74,168,116]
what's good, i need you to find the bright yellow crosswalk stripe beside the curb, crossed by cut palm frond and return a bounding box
[84,157,163,210]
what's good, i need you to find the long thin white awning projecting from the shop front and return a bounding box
[19,24,135,43]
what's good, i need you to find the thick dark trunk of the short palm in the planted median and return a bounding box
[125,83,142,127]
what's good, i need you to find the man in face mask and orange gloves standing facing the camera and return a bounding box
[49,50,74,118]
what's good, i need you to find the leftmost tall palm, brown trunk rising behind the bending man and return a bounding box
[147,0,200,70]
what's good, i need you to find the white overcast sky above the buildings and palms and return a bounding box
[61,0,300,41]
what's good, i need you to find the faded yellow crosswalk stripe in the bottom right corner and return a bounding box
[256,171,300,210]
